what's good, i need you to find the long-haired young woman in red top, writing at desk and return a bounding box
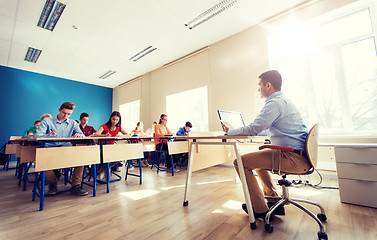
[93,111,129,175]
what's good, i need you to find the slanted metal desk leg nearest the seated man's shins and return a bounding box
[233,143,257,230]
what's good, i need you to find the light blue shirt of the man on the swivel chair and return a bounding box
[228,91,308,151]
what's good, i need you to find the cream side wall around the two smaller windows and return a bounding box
[113,0,355,131]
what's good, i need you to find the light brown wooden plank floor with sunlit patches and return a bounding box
[0,163,377,240]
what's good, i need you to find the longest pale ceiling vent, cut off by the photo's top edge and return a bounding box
[185,0,238,29]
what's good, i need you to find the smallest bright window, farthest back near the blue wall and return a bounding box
[119,100,140,133]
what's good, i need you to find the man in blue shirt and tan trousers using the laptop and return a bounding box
[223,70,310,219]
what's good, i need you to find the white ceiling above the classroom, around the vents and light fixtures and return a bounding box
[0,0,304,87]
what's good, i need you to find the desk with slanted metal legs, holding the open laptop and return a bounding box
[183,136,265,229]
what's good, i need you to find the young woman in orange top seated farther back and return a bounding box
[154,114,173,168]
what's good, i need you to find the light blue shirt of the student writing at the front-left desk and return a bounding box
[34,117,85,147]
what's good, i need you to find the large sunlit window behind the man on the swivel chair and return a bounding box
[269,1,377,135]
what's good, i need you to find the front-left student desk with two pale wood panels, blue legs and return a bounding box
[26,136,155,211]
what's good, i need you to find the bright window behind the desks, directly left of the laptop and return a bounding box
[166,86,209,133]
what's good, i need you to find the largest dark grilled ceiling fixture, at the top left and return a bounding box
[37,0,66,31]
